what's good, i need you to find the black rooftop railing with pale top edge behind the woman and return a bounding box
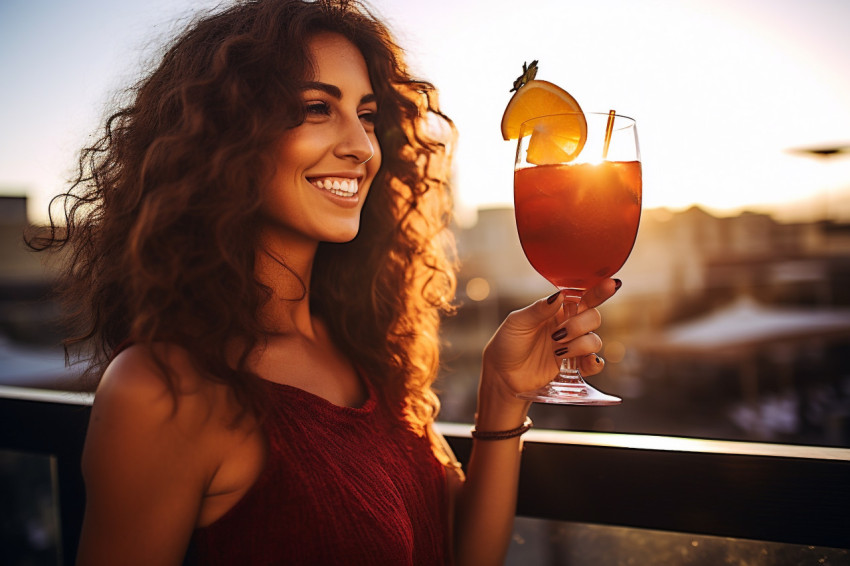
[0,386,850,564]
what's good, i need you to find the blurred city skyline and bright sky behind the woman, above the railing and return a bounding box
[0,0,850,446]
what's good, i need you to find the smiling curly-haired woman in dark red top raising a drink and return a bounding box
[34,0,615,566]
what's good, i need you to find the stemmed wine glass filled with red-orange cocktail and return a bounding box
[514,112,642,405]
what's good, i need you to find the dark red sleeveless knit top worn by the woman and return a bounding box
[187,380,451,566]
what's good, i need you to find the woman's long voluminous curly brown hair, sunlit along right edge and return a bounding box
[30,0,456,431]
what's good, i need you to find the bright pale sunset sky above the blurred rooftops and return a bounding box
[0,0,850,226]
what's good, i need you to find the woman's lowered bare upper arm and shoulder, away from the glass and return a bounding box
[77,348,214,566]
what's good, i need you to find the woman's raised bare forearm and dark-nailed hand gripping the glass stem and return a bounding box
[455,280,615,566]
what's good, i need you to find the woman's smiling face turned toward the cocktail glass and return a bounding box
[256,33,381,247]
